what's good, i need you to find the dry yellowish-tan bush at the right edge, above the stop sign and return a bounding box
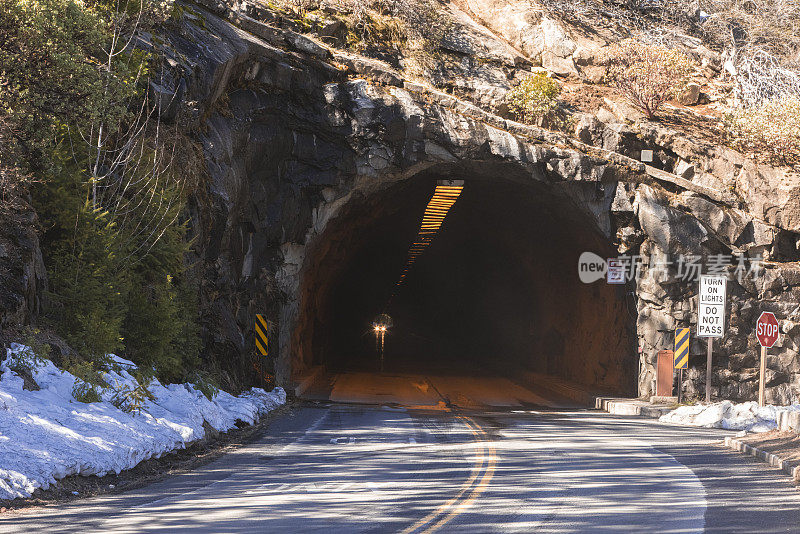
[726,96,800,165]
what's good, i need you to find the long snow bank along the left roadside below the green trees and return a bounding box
[0,343,286,499]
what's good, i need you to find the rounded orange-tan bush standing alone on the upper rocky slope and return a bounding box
[606,39,692,119]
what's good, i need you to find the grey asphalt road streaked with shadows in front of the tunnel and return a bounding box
[0,402,800,533]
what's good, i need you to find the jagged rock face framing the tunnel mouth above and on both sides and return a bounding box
[152,1,800,402]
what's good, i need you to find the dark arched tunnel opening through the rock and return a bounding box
[291,163,638,406]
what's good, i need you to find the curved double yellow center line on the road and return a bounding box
[402,416,497,534]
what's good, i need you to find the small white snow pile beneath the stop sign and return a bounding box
[659,401,800,432]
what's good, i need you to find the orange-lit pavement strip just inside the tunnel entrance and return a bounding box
[294,370,578,409]
